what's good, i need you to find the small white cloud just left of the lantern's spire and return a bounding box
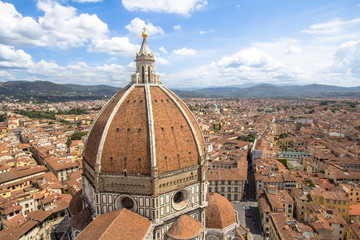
[88,37,140,56]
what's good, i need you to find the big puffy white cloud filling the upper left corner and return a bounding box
[0,1,109,48]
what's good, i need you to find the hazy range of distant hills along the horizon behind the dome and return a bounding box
[0,81,360,101]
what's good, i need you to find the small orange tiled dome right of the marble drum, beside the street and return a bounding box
[206,192,236,229]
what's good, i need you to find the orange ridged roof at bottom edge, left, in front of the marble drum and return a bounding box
[76,208,151,240]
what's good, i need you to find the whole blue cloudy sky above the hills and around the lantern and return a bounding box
[0,0,360,88]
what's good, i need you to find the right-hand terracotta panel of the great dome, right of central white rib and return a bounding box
[150,87,199,173]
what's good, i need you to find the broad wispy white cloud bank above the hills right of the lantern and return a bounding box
[162,15,360,87]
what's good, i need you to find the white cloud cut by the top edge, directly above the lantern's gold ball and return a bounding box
[122,0,207,16]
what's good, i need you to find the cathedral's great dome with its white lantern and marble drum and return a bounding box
[82,30,207,239]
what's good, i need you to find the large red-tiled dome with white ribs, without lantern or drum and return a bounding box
[84,84,204,176]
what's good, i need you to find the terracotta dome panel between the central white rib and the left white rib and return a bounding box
[101,86,151,175]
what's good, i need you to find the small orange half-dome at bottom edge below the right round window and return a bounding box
[166,214,202,239]
